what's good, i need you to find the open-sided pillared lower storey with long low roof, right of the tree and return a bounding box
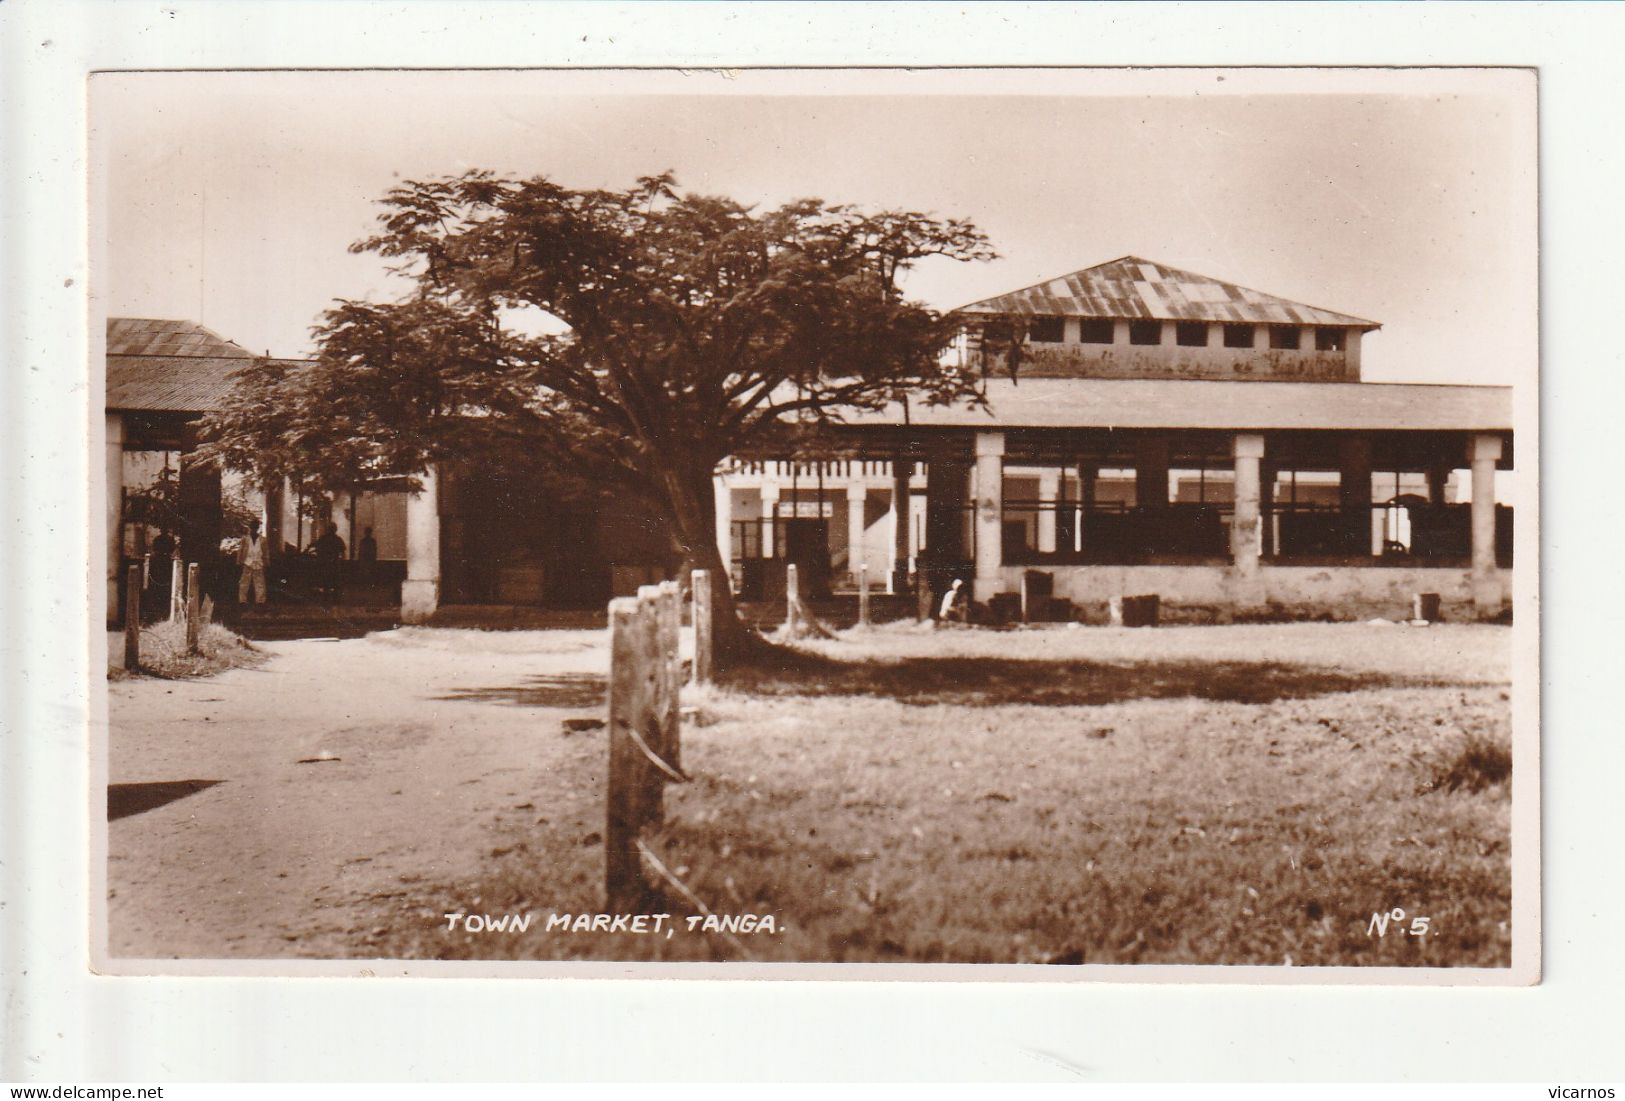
[718,378,1513,619]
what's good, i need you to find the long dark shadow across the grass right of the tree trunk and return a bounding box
[726,653,1441,706]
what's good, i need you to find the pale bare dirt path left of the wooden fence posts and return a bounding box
[107,630,608,958]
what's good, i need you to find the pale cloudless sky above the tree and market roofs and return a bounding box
[89,70,1537,383]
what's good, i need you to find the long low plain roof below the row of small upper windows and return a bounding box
[845,378,1513,432]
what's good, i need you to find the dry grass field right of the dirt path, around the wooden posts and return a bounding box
[382,625,1510,966]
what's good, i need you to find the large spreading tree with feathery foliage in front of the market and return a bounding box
[198,172,995,661]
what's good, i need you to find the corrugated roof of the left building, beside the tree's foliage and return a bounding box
[107,317,304,412]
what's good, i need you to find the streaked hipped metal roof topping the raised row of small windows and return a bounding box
[959,257,1381,330]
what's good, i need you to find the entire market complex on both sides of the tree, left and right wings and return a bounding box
[107,257,1513,622]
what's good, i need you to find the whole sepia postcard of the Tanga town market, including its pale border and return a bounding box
[88,68,1541,984]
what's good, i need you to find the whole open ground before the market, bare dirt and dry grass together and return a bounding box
[107,624,1532,966]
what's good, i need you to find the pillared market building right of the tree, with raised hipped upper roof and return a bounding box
[717,257,1513,617]
